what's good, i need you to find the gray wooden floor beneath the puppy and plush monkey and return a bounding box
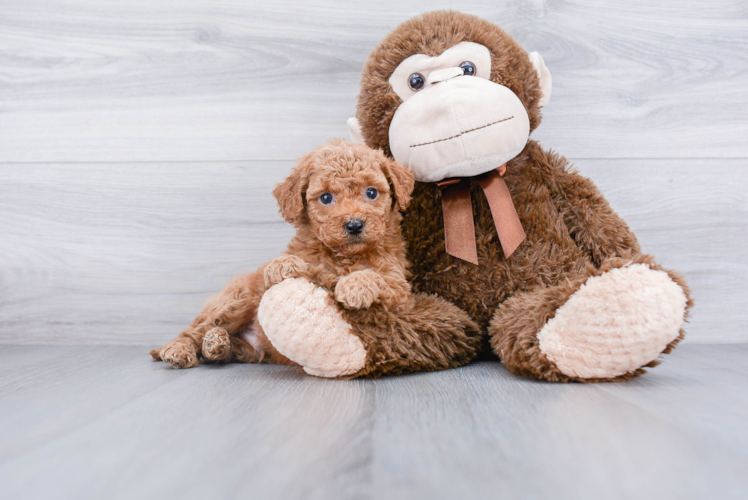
[0,345,748,500]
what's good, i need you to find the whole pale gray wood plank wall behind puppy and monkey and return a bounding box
[0,0,748,344]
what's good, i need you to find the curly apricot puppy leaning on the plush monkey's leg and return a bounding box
[150,141,414,368]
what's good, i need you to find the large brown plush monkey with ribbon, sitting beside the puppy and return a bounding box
[258,11,692,382]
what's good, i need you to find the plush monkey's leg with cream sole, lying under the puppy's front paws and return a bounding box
[258,273,483,378]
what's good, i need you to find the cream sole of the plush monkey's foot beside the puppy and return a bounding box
[257,278,366,378]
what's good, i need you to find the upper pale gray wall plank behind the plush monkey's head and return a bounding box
[0,0,748,162]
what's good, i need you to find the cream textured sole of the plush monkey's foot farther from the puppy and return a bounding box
[538,264,688,379]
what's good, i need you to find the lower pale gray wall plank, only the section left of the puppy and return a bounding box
[0,162,293,344]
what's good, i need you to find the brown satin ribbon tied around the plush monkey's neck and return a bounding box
[436,163,525,265]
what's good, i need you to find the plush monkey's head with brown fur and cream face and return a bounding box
[349,11,551,182]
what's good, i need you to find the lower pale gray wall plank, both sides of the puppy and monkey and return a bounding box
[0,159,748,345]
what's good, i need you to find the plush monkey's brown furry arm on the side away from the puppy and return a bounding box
[538,147,641,266]
